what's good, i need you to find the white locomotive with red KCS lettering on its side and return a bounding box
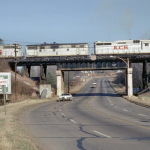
[94,40,150,55]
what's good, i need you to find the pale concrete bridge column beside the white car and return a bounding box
[56,70,64,96]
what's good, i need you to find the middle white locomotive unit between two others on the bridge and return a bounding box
[26,43,89,57]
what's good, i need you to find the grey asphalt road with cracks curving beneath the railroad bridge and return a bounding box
[21,78,150,150]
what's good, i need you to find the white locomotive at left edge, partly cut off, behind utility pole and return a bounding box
[0,44,22,58]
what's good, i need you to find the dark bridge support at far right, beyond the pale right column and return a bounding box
[142,60,148,89]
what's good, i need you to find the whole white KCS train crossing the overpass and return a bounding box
[0,40,150,58]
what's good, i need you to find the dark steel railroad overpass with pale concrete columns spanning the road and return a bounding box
[8,54,150,96]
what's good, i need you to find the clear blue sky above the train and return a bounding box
[0,0,150,45]
